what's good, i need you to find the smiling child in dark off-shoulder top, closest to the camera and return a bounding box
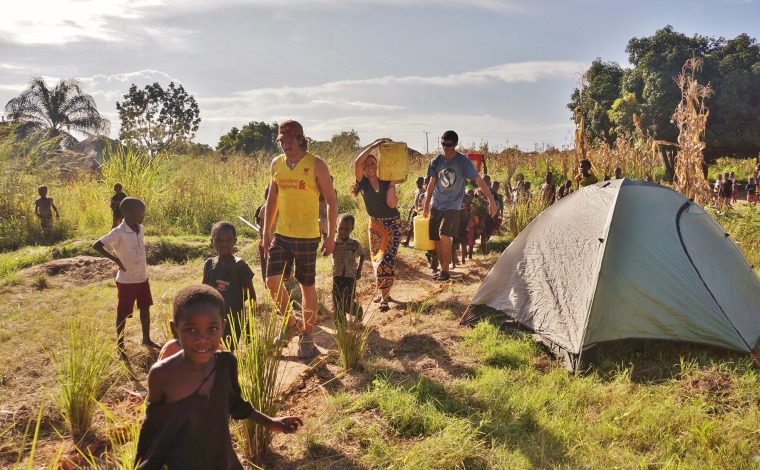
[134,284,303,469]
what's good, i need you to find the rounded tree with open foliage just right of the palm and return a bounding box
[116,82,201,156]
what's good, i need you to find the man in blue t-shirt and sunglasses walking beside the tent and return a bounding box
[422,131,497,281]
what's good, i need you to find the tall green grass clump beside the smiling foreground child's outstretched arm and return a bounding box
[233,303,290,462]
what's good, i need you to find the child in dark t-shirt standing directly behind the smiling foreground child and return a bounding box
[202,222,256,345]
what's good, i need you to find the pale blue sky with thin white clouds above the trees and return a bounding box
[0,0,760,152]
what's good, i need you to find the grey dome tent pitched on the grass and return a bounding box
[460,179,760,369]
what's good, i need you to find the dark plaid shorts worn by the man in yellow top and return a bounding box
[267,233,320,286]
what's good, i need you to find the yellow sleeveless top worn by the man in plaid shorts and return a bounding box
[272,152,319,238]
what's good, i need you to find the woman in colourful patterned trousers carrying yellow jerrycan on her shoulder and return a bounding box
[352,138,407,312]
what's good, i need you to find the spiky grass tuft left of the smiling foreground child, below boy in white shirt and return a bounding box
[51,318,121,440]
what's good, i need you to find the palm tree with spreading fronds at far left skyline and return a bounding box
[5,77,110,148]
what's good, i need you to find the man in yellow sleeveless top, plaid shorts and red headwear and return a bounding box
[261,120,338,358]
